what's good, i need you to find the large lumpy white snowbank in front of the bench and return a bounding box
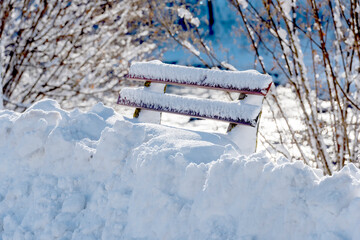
[0,100,360,240]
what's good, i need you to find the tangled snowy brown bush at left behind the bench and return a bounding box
[0,0,160,110]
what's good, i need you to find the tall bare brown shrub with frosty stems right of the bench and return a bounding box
[225,0,360,174]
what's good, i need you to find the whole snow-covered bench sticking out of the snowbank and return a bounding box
[118,61,272,154]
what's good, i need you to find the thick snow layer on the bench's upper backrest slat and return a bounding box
[129,60,272,93]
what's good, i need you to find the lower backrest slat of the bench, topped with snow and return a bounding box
[118,88,261,127]
